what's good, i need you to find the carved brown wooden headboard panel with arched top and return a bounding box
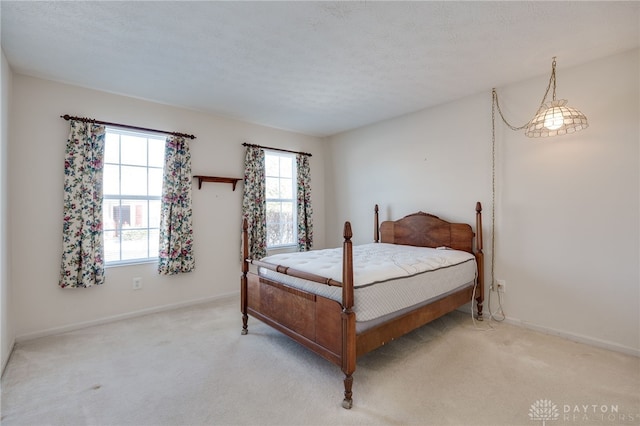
[380,212,474,254]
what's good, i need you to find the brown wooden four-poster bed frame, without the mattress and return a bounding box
[240,202,484,409]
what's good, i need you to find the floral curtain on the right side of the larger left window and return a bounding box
[158,136,195,275]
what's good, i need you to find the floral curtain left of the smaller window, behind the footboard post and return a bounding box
[242,146,267,259]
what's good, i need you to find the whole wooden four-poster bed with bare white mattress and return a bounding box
[240,202,484,409]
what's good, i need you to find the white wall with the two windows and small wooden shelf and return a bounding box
[9,74,325,340]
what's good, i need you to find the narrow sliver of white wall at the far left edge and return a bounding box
[0,48,15,372]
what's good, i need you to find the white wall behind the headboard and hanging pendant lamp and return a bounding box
[326,50,640,355]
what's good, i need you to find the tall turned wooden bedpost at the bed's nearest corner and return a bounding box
[342,222,356,409]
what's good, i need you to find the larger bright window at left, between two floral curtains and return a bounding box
[102,127,165,265]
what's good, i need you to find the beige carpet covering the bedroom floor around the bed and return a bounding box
[1,299,640,426]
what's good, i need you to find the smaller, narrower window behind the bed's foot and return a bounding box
[265,151,298,248]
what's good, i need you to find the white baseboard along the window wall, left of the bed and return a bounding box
[14,291,240,344]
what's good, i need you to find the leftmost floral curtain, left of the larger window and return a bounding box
[58,120,105,288]
